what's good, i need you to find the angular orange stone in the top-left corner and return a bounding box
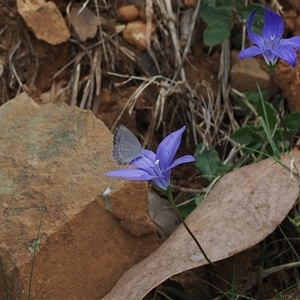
[17,0,70,45]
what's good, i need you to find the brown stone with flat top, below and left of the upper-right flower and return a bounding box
[230,51,271,93]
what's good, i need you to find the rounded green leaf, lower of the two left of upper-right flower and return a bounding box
[203,21,232,46]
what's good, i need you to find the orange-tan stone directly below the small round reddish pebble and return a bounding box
[123,20,155,51]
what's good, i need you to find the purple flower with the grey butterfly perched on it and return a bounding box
[105,126,195,190]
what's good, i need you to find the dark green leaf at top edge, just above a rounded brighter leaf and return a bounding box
[199,5,232,24]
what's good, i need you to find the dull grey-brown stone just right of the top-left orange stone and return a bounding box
[70,7,99,42]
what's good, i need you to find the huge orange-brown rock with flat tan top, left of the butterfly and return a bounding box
[0,94,157,300]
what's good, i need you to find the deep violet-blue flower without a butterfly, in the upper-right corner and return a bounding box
[239,6,300,67]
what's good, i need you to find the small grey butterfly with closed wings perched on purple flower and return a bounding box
[112,125,143,165]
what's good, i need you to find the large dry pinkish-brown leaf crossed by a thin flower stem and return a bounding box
[103,150,300,300]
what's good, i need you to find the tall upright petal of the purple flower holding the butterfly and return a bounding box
[156,126,186,170]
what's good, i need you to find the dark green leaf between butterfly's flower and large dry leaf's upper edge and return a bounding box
[195,144,233,181]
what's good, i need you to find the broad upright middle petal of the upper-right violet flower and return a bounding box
[262,6,284,40]
